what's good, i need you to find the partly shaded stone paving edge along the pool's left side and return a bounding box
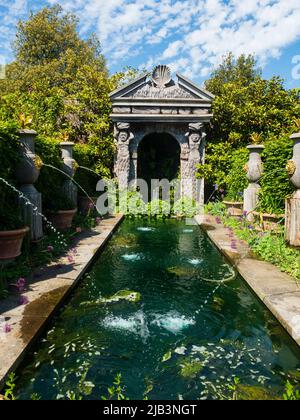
[0,215,124,390]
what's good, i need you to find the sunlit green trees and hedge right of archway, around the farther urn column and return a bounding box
[203,54,300,205]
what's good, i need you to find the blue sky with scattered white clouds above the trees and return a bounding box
[0,0,300,88]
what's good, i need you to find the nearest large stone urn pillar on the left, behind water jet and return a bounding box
[16,130,43,242]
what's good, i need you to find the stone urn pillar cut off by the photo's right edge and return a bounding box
[285,133,300,247]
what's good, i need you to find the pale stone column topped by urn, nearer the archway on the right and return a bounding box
[244,144,264,221]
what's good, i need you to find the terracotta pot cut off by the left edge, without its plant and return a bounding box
[0,227,29,261]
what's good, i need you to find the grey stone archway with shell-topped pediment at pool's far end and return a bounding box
[110,66,214,206]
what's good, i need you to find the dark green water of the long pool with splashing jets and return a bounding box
[17,220,300,400]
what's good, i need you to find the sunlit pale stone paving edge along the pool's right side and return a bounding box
[194,215,300,346]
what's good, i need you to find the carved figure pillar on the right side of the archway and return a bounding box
[184,123,206,203]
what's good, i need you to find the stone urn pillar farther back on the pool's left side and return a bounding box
[60,142,78,207]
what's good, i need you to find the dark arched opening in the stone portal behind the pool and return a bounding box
[138,133,180,186]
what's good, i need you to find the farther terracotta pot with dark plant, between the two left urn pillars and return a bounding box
[44,191,77,230]
